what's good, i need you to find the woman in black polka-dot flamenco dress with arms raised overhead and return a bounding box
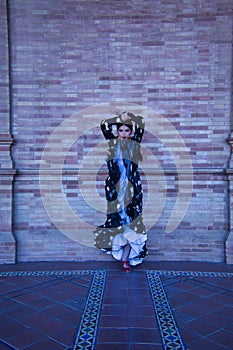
[95,112,148,272]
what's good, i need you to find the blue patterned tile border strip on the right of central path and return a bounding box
[146,270,233,350]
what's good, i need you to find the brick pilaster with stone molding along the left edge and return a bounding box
[0,1,16,264]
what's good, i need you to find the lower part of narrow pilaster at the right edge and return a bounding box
[225,133,233,264]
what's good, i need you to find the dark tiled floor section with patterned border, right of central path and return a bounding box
[147,270,233,350]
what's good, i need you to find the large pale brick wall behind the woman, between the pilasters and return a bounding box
[0,0,232,262]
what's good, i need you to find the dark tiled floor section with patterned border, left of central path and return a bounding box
[0,270,106,350]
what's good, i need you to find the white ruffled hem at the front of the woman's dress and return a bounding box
[112,227,147,266]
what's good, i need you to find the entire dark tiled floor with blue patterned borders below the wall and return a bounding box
[0,261,233,350]
